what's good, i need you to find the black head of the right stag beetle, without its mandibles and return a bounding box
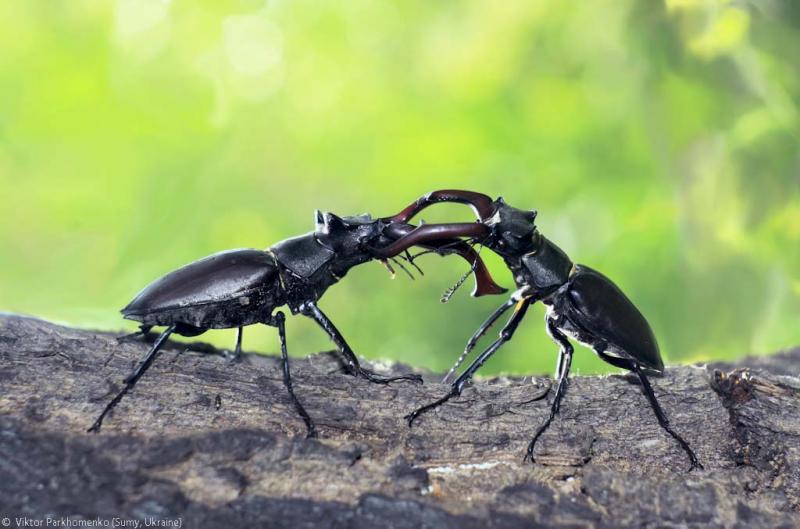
[483,197,536,256]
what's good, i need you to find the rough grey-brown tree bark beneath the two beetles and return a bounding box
[0,316,800,529]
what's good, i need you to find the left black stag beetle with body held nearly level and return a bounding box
[89,211,505,437]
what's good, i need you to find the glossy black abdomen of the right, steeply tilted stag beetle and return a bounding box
[560,265,664,371]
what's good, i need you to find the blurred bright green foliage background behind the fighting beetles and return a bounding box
[0,0,800,373]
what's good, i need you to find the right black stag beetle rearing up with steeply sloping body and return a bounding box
[375,190,703,470]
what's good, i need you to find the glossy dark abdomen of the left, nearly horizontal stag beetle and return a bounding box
[122,249,278,328]
